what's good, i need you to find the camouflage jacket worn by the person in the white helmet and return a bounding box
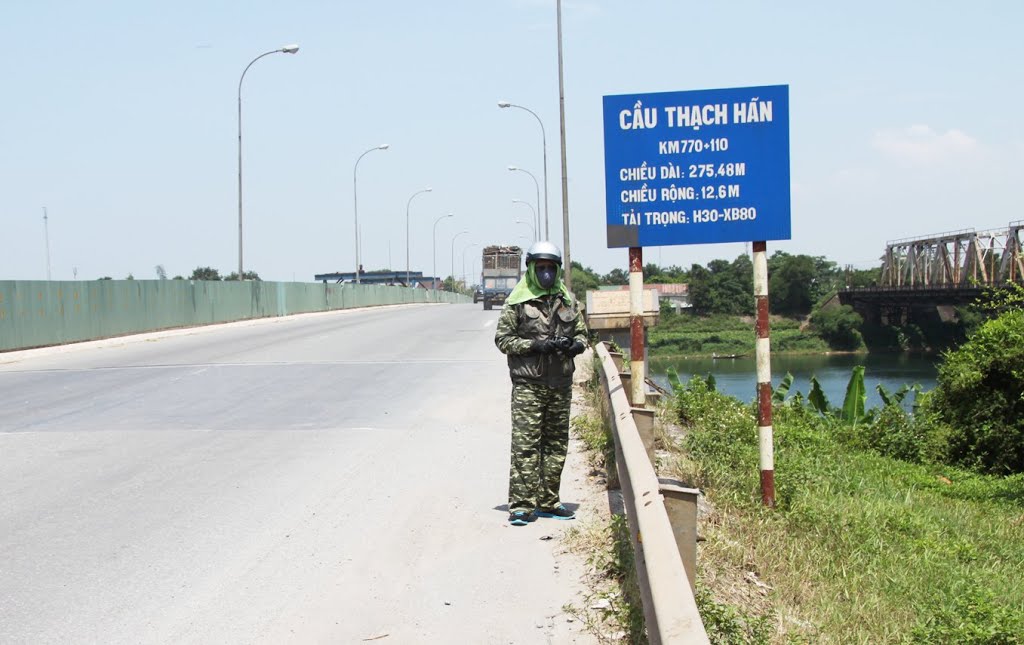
[495,295,587,387]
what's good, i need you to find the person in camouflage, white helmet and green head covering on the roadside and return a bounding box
[495,242,587,526]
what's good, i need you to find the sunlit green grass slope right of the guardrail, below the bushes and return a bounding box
[669,383,1024,643]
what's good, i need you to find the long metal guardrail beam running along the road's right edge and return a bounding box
[596,343,710,645]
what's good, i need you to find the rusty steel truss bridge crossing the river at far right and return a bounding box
[839,220,1024,324]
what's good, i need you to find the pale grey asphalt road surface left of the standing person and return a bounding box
[0,304,591,643]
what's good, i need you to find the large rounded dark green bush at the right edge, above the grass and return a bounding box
[934,309,1024,474]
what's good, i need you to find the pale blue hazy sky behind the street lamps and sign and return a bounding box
[0,0,1024,282]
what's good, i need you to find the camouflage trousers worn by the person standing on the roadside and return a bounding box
[509,383,572,512]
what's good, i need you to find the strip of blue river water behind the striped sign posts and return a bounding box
[648,354,939,407]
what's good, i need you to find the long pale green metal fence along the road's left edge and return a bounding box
[0,280,469,351]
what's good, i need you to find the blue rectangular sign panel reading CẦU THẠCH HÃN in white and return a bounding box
[604,85,791,248]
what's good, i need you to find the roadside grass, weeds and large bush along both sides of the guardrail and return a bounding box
[573,289,1024,645]
